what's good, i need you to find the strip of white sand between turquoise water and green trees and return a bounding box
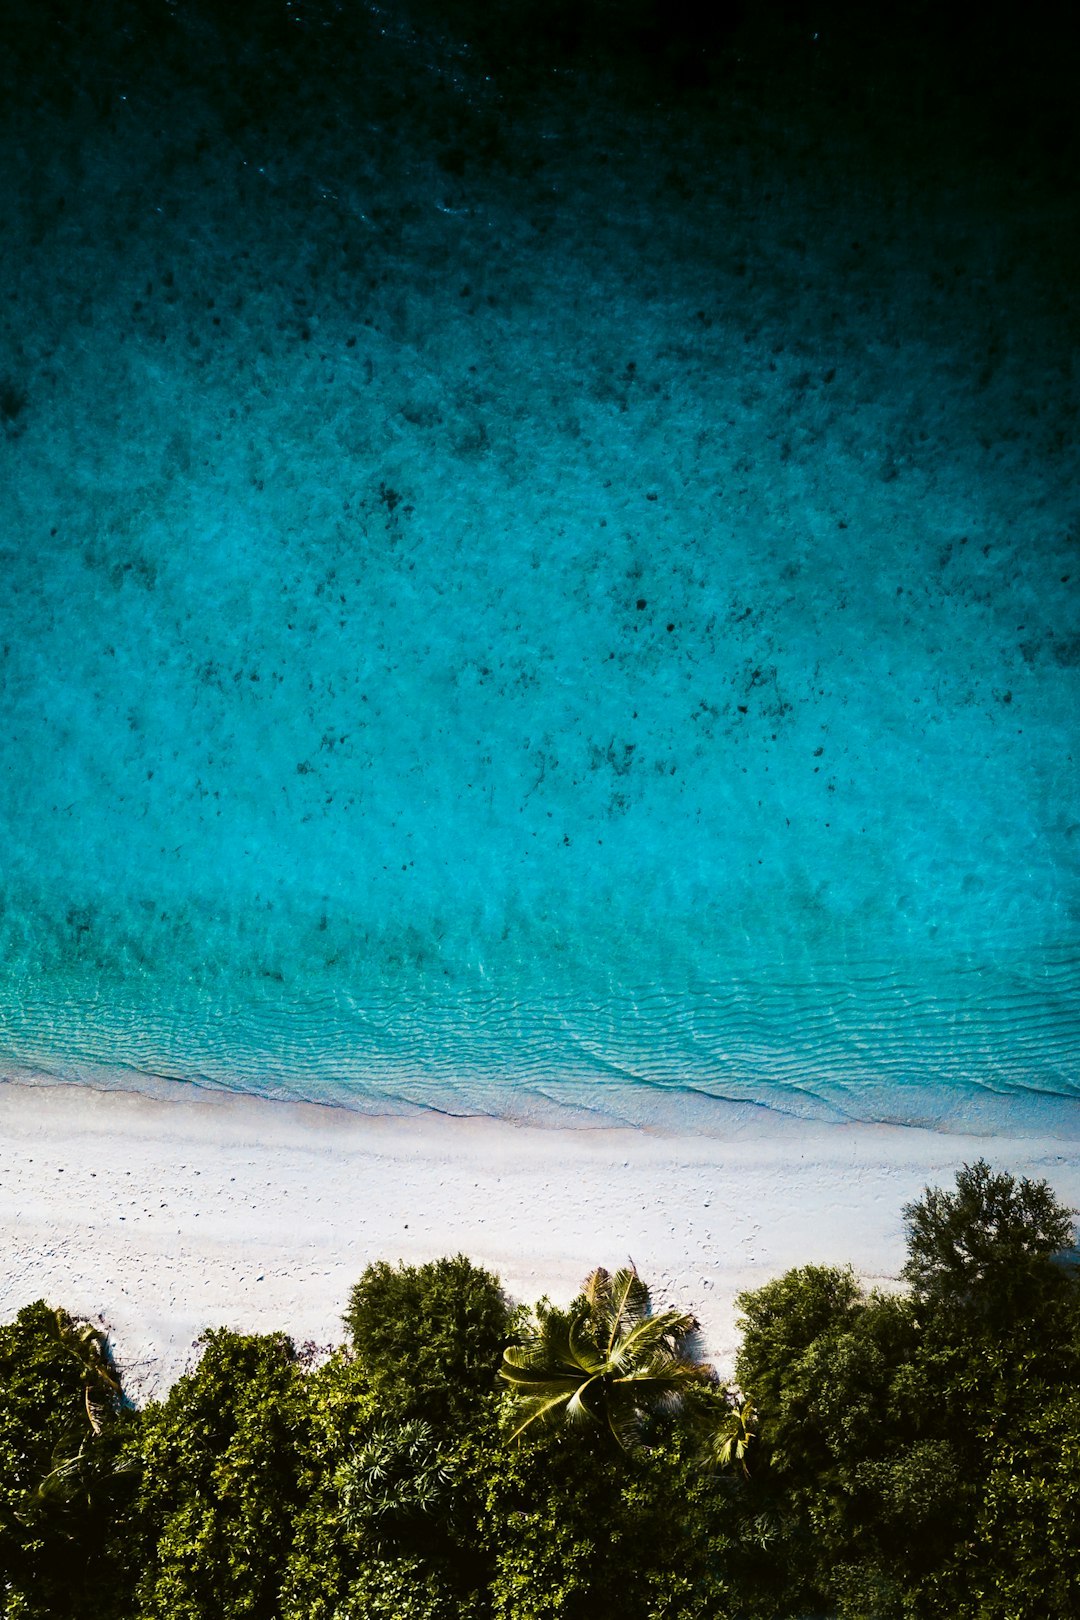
[0,1084,1080,1396]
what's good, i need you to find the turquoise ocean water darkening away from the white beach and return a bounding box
[0,9,1080,1131]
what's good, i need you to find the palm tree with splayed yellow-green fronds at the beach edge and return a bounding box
[499,1267,716,1452]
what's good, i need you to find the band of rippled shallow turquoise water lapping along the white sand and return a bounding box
[0,949,1080,1129]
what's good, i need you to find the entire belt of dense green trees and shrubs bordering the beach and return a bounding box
[0,1163,1080,1620]
